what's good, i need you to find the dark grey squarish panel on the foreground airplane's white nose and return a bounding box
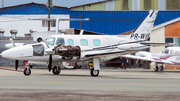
[32,44,44,56]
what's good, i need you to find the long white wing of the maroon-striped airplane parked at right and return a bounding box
[121,55,173,64]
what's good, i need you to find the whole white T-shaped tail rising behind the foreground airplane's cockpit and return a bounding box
[28,18,90,34]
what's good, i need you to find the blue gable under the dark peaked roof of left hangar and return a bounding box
[0,2,69,15]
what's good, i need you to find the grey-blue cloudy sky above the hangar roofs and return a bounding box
[0,0,104,7]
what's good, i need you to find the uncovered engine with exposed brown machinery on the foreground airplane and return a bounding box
[55,45,81,59]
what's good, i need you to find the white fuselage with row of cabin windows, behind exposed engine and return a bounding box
[2,35,148,62]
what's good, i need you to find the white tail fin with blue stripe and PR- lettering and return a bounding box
[129,10,158,40]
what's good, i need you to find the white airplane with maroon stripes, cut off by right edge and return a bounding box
[122,47,180,71]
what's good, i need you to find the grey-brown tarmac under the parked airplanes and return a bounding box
[0,66,180,101]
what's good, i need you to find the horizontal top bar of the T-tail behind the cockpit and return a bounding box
[28,18,90,21]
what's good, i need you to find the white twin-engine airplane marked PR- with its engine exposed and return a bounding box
[2,10,175,76]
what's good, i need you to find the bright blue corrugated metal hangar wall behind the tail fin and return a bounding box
[70,11,180,35]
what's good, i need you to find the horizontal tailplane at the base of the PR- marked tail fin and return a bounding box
[141,41,178,47]
